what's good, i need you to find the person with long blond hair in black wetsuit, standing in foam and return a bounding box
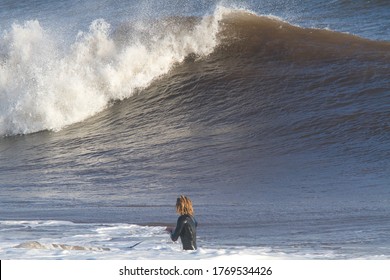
[169,195,198,250]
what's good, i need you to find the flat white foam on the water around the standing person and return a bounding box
[0,221,304,260]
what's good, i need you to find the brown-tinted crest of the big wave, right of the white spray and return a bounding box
[213,11,390,63]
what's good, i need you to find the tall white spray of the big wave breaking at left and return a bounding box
[0,4,233,136]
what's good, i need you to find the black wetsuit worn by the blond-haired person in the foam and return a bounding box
[171,215,198,250]
